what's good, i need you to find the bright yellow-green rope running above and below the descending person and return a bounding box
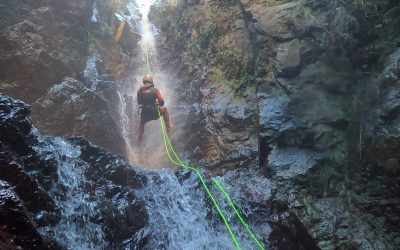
[145,28,265,250]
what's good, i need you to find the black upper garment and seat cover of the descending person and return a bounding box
[137,83,159,124]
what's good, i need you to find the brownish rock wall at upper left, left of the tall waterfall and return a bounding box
[0,0,139,158]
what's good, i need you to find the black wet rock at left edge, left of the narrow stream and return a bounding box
[0,94,57,217]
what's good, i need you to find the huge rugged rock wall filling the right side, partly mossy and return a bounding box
[152,1,400,249]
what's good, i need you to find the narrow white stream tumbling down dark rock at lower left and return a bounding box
[37,138,106,250]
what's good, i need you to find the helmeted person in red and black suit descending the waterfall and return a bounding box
[137,75,172,142]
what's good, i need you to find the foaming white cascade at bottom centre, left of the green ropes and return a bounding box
[134,171,235,250]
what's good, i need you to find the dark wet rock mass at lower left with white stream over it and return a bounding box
[0,94,148,249]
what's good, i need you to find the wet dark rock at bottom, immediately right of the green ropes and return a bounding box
[214,169,319,249]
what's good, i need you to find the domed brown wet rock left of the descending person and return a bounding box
[32,78,126,155]
